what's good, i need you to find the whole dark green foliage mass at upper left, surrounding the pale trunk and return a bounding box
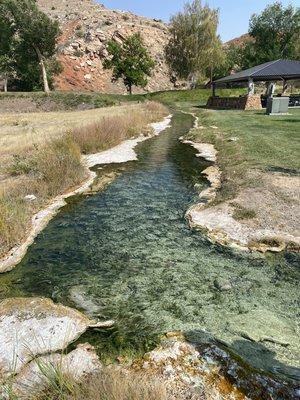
[0,0,61,91]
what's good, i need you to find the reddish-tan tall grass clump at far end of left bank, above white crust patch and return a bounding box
[72,102,167,154]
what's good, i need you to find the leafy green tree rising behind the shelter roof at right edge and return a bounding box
[243,2,300,68]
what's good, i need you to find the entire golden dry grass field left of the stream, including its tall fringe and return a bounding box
[0,102,168,257]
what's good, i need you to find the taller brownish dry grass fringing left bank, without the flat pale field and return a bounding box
[0,102,167,257]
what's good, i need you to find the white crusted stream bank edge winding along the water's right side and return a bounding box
[180,113,300,253]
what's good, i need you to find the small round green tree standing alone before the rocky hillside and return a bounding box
[104,33,155,94]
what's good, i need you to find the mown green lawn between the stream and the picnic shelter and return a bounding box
[185,109,300,201]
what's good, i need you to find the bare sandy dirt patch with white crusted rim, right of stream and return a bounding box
[187,170,300,252]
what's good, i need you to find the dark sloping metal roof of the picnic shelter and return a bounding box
[214,60,300,83]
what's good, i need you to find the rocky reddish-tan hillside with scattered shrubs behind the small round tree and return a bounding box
[38,0,173,93]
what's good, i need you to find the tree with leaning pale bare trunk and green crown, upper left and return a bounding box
[2,0,59,93]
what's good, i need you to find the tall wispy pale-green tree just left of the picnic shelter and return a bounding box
[165,0,223,86]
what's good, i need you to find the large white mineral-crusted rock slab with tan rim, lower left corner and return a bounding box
[0,298,93,382]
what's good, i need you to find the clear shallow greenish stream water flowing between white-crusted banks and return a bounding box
[0,113,300,380]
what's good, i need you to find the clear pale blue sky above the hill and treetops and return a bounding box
[97,0,300,41]
